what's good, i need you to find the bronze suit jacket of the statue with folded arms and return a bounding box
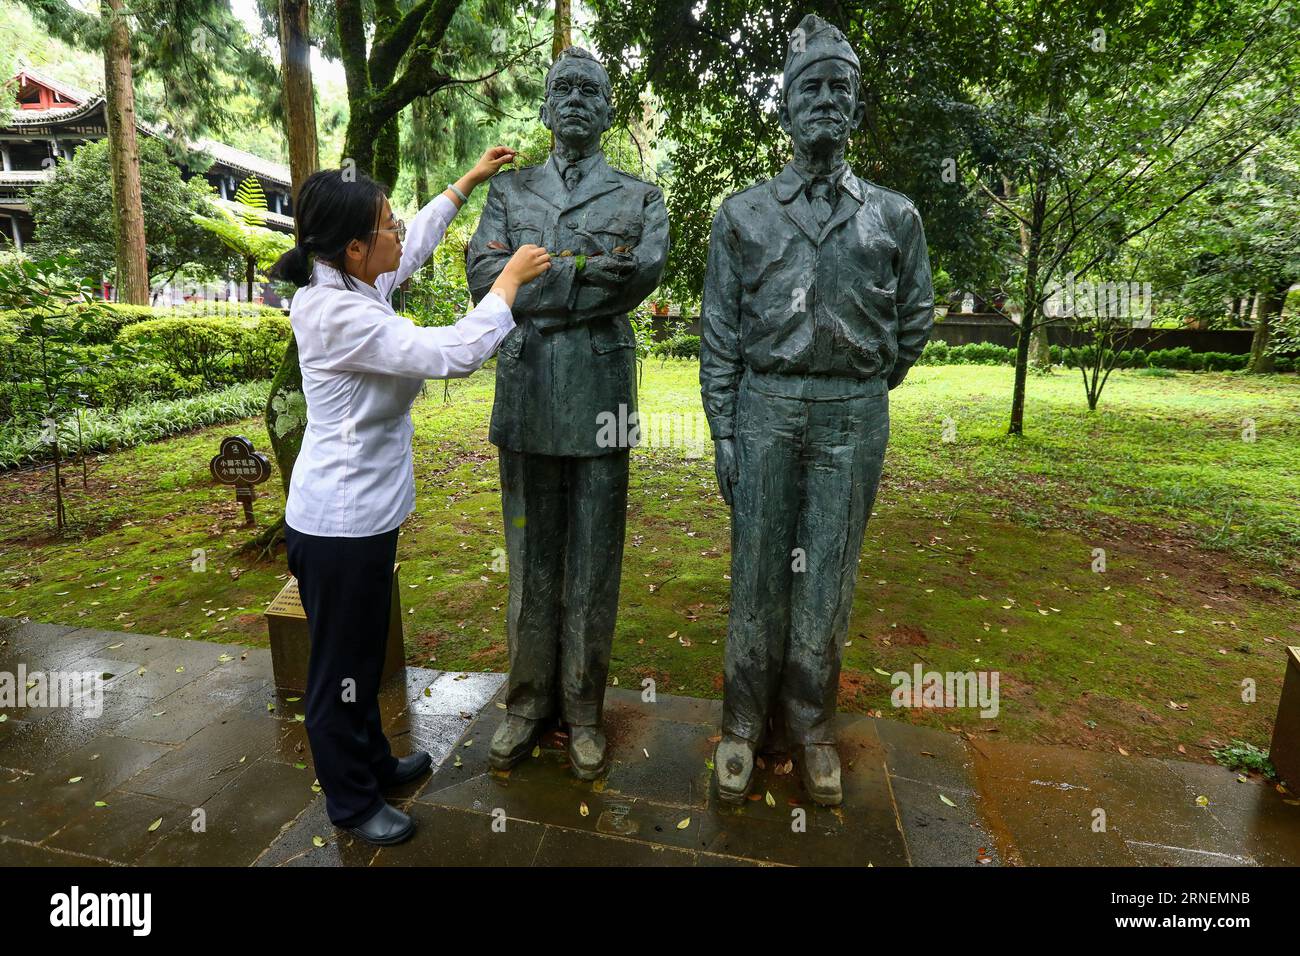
[465,155,668,457]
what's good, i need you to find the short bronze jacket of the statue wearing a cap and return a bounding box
[699,164,935,438]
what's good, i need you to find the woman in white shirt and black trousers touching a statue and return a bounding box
[272,146,550,845]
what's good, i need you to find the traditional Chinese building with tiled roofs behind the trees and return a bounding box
[0,66,294,250]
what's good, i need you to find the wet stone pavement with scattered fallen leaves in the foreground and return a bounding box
[0,618,1300,866]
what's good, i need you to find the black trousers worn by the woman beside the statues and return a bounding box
[285,525,398,826]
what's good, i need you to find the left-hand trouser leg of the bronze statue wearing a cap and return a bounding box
[723,375,806,744]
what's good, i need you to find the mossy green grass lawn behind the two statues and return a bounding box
[0,360,1300,758]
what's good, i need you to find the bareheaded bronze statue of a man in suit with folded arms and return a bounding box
[465,47,668,779]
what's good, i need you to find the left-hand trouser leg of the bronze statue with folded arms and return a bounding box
[499,447,567,721]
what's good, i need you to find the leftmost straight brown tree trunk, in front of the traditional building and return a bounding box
[103,0,150,306]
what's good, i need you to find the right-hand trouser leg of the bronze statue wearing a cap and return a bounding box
[780,378,889,745]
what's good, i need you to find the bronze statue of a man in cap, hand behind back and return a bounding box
[699,14,933,805]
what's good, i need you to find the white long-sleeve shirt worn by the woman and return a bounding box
[285,195,515,537]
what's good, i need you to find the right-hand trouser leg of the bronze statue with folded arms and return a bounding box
[553,449,629,726]
